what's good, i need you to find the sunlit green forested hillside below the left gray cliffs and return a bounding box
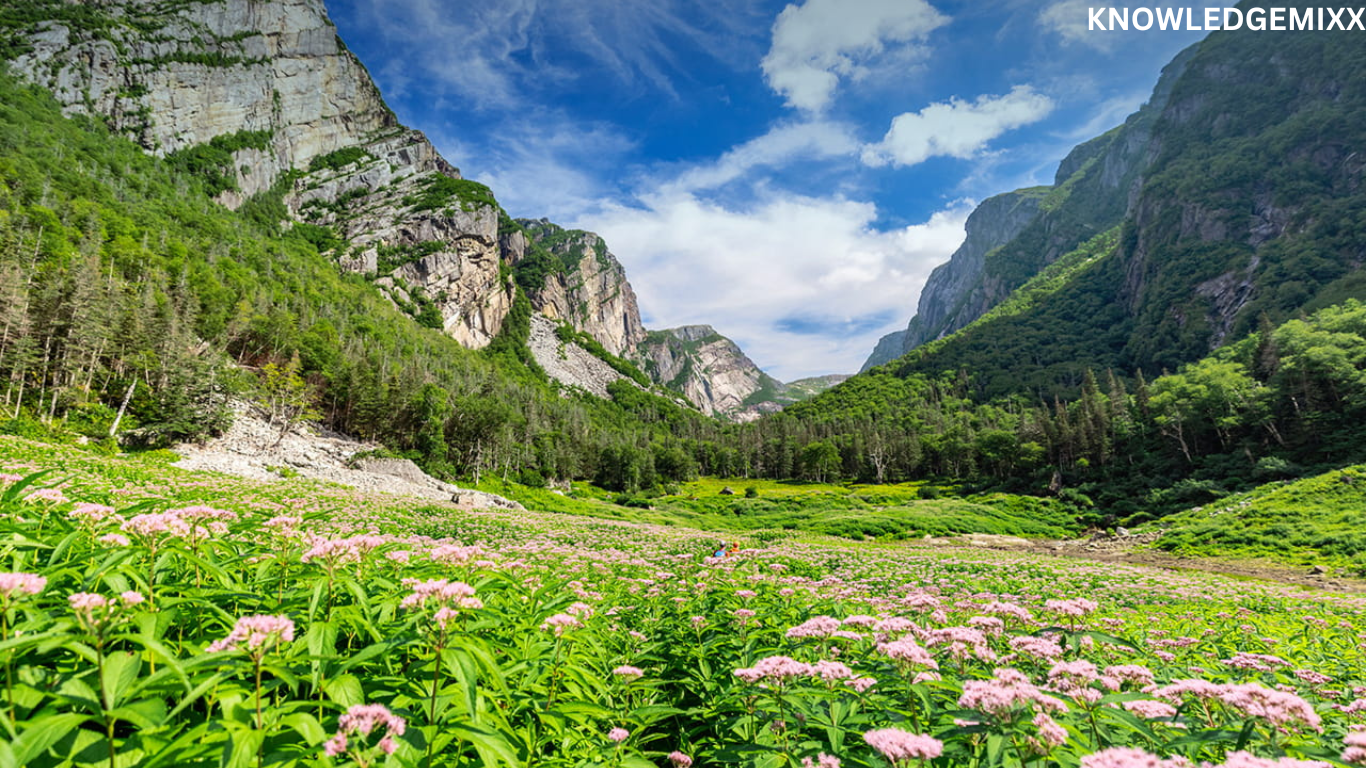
[0,71,702,477]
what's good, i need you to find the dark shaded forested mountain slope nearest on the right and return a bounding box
[895,10,1366,396]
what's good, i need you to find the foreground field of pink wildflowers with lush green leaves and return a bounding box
[0,431,1366,768]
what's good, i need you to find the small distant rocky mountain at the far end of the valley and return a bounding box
[635,325,847,422]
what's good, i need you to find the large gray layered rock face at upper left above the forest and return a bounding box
[10,0,510,347]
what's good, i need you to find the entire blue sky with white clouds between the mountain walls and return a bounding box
[326,0,1221,381]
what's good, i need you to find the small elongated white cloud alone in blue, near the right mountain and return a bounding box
[863,86,1053,165]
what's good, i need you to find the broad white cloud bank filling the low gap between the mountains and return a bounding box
[575,193,971,381]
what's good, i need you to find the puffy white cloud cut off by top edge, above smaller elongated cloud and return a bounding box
[762,0,948,111]
